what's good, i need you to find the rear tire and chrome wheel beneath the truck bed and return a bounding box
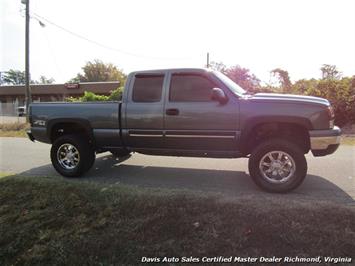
[51,135,95,177]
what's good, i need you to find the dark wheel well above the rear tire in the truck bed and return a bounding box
[50,122,92,143]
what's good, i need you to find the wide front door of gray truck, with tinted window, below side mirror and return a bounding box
[164,72,239,151]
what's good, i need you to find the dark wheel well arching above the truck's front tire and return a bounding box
[244,123,310,154]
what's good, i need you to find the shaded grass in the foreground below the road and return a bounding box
[0,176,355,265]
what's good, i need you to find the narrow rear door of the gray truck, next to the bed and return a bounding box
[125,73,165,149]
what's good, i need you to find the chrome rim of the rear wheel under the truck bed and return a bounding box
[57,143,80,170]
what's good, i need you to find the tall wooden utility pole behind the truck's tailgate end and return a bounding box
[21,0,32,117]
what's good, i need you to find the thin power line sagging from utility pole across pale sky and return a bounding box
[32,13,197,60]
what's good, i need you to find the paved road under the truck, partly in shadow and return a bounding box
[0,138,355,206]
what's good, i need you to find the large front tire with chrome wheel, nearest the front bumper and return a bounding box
[249,139,307,193]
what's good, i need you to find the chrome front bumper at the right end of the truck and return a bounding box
[309,126,341,156]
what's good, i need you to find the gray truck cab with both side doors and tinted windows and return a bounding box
[122,69,244,157]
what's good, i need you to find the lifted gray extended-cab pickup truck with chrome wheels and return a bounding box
[28,69,341,192]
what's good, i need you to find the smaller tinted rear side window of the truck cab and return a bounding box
[132,74,164,102]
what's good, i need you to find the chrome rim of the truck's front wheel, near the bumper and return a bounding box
[259,151,296,183]
